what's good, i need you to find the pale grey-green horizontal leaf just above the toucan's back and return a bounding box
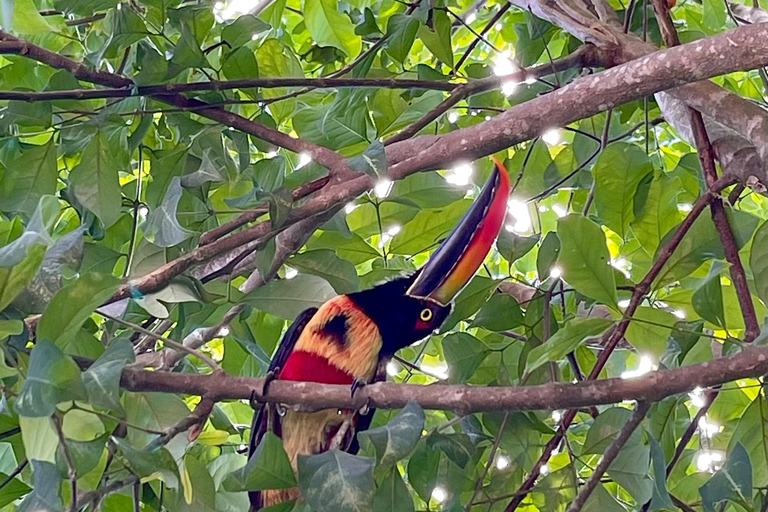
[240,274,336,320]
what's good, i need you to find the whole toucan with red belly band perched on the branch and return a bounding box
[249,160,510,510]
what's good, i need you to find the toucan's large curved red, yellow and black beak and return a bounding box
[406,158,510,306]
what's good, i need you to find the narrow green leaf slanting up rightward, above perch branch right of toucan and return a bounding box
[525,317,613,373]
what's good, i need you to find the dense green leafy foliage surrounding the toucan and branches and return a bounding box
[0,0,768,512]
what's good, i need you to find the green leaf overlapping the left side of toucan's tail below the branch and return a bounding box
[223,432,296,492]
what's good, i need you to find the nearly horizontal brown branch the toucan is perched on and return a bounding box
[114,347,768,414]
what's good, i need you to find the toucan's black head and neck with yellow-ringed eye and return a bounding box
[349,274,451,357]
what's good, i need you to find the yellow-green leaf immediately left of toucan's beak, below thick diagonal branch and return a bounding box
[389,200,472,254]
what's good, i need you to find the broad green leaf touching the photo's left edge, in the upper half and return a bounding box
[0,139,58,217]
